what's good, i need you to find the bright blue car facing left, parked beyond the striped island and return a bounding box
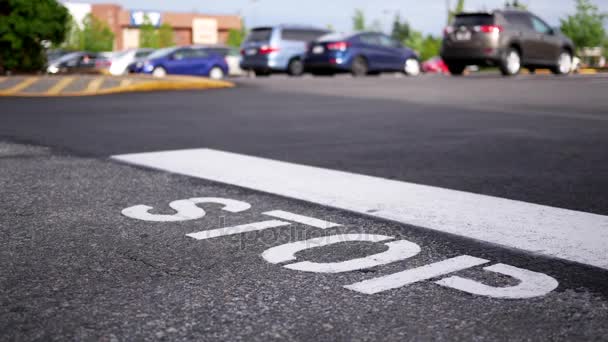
[135,46,228,79]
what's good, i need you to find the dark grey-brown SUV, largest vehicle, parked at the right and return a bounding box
[441,10,574,76]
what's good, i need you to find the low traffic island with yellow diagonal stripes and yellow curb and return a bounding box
[0,75,234,97]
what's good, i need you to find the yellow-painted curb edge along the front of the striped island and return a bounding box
[0,76,235,97]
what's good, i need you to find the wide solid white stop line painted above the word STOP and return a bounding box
[113,149,608,269]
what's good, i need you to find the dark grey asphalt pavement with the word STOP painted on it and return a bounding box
[0,75,608,341]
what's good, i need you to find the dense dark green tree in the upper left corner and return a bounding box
[0,0,70,73]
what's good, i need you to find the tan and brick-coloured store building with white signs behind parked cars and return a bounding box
[63,2,242,50]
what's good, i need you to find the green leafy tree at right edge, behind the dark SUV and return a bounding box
[561,0,606,49]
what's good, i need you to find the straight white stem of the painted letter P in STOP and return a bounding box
[344,255,490,294]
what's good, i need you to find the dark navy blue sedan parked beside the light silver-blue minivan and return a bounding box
[304,32,421,76]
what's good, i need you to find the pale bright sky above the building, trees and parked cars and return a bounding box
[78,0,608,35]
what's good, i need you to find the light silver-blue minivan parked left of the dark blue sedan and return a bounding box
[241,25,329,76]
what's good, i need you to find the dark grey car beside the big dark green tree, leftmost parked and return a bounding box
[46,51,109,74]
